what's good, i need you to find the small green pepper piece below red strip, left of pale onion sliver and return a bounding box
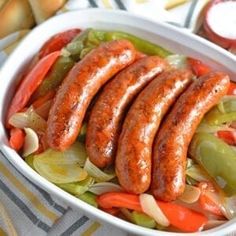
[131,211,156,229]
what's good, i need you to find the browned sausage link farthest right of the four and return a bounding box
[151,72,229,201]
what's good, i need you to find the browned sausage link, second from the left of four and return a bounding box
[86,56,167,168]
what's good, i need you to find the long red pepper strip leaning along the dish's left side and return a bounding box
[7,51,60,128]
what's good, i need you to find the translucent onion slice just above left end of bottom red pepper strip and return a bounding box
[89,182,123,195]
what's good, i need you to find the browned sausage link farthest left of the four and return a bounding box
[47,40,136,151]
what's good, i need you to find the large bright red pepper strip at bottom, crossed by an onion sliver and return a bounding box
[97,192,207,232]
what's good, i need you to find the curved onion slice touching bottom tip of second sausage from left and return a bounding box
[84,158,115,182]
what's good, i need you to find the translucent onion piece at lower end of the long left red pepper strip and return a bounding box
[9,107,47,131]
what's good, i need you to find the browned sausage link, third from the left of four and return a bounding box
[116,70,192,194]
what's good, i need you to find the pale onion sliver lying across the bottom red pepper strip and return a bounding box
[139,193,170,227]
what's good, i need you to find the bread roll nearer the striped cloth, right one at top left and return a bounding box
[29,0,66,24]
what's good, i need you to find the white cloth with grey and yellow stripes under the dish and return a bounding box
[0,0,210,236]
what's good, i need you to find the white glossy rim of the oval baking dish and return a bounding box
[0,9,236,236]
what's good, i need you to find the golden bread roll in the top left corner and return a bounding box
[0,0,35,39]
